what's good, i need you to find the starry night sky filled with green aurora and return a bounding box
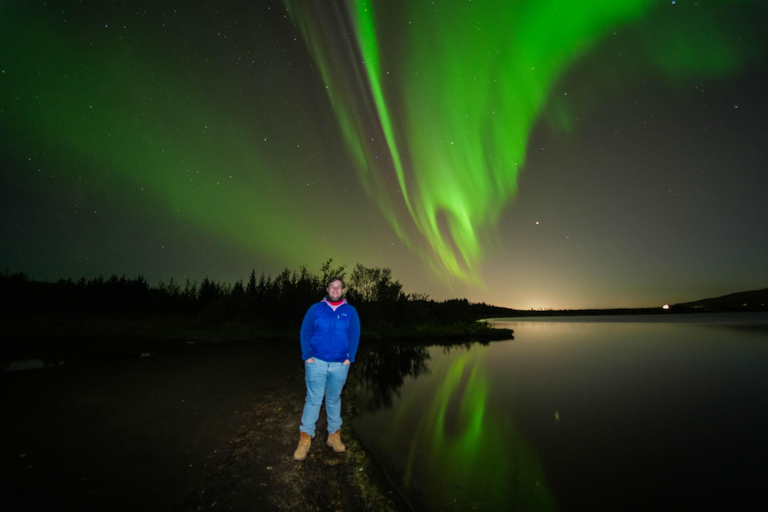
[0,0,768,309]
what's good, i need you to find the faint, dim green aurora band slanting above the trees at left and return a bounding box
[0,5,332,264]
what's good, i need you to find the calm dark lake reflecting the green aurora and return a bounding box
[353,313,768,511]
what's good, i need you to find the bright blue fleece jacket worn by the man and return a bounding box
[300,300,360,363]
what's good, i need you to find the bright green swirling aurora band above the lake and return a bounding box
[285,0,764,285]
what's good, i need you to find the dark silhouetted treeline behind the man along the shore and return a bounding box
[0,259,511,337]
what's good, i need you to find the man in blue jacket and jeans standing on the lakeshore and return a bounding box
[293,277,360,460]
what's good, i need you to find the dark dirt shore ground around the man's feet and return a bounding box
[0,342,409,512]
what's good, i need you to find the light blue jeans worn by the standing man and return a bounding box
[299,357,350,437]
